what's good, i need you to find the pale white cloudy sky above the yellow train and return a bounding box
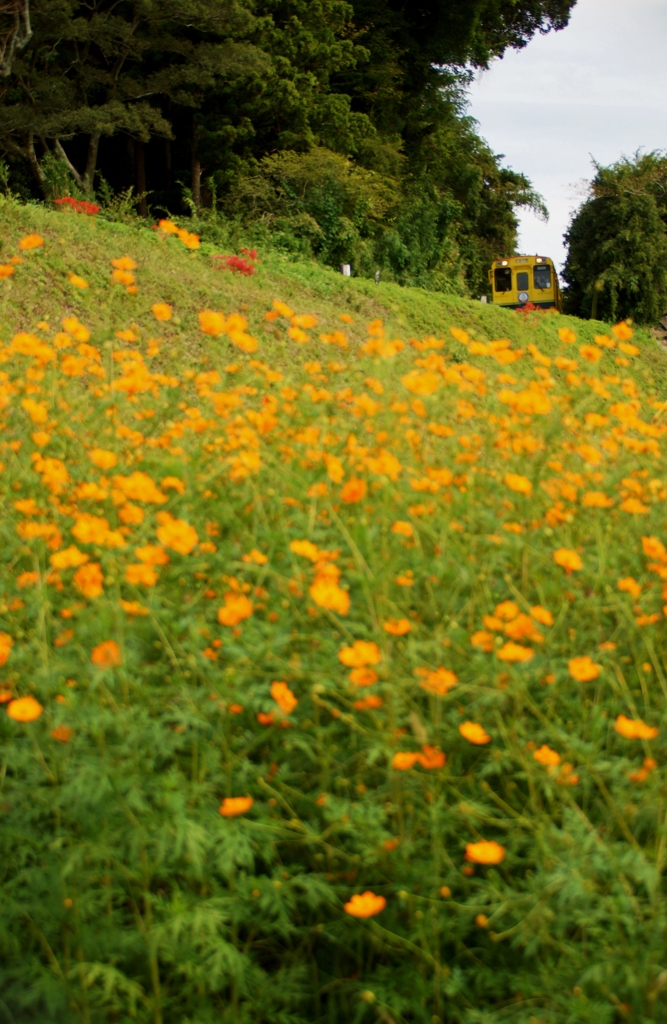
[469,0,667,265]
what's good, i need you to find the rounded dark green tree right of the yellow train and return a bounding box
[564,153,667,324]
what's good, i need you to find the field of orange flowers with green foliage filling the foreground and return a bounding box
[0,222,667,1024]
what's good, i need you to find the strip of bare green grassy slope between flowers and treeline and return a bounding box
[0,200,667,381]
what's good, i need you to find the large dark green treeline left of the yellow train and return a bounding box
[0,0,576,294]
